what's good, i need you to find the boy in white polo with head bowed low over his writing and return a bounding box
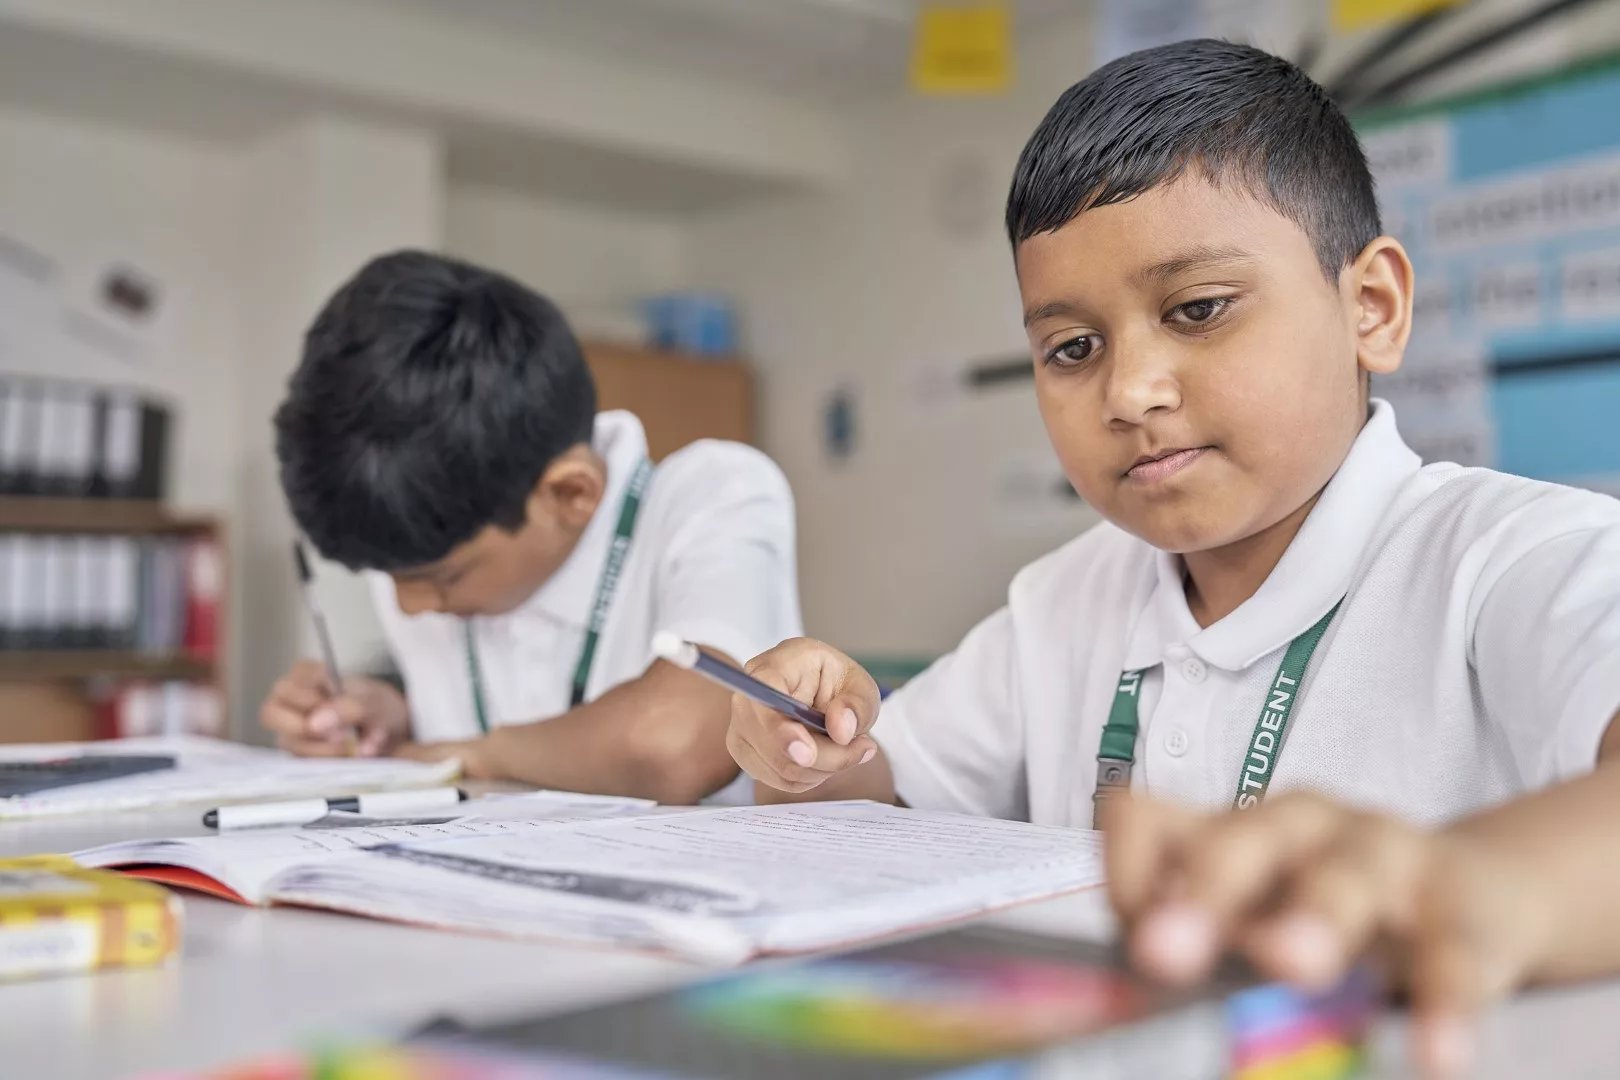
[261,251,800,803]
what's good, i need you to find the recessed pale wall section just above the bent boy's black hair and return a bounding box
[444,185,687,337]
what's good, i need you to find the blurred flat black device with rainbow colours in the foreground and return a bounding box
[418,926,1375,1080]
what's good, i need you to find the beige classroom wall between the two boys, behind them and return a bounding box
[690,26,1095,656]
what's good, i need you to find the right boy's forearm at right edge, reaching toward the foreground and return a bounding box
[1452,716,1620,981]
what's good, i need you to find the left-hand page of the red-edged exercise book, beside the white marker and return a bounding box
[73,792,654,904]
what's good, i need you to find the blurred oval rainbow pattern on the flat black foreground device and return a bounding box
[685,959,1144,1059]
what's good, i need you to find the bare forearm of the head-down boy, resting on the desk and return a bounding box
[462,664,737,805]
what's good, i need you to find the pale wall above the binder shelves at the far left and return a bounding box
[0,107,241,513]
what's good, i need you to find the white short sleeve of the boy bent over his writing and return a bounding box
[654,444,804,662]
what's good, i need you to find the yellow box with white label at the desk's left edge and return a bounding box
[0,855,180,980]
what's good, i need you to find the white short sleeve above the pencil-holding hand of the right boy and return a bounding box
[872,609,1029,819]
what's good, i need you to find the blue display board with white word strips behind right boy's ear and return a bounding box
[1358,57,1620,494]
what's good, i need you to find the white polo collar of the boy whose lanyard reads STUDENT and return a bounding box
[1124,398,1422,672]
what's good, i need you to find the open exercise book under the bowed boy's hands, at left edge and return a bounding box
[0,735,462,821]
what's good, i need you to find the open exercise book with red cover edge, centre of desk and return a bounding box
[76,795,1103,963]
